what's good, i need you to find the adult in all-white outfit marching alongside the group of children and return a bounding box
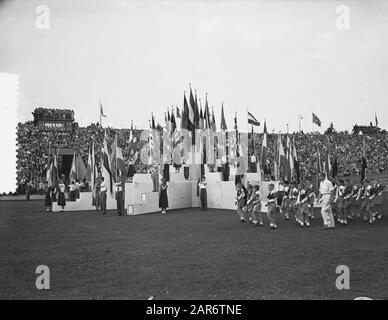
[318,172,335,230]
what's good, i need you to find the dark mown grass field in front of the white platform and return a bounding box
[0,201,388,299]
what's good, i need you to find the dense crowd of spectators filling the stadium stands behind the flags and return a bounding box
[17,119,388,192]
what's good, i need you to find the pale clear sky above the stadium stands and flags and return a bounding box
[0,0,388,132]
